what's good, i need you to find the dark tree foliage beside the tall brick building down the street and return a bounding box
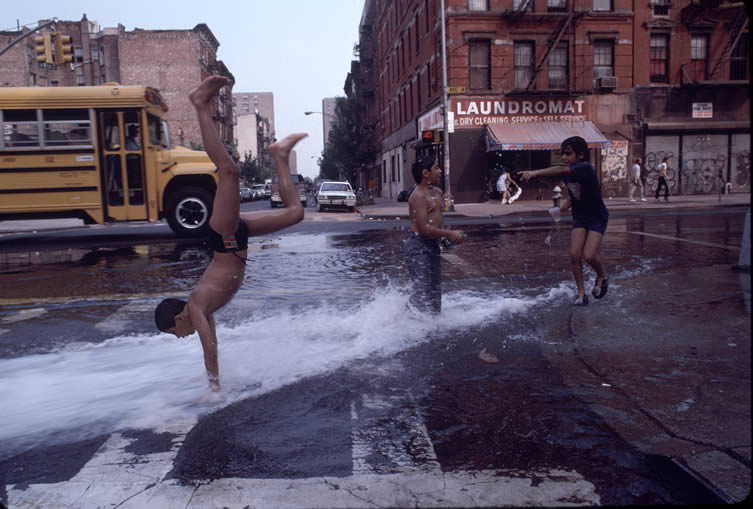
[319,97,379,186]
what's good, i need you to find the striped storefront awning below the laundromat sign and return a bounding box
[486,121,609,152]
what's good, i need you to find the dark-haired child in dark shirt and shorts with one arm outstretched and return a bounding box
[520,136,609,306]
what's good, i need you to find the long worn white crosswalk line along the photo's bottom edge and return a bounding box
[8,464,600,509]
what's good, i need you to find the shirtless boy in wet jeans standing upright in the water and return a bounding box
[404,156,465,313]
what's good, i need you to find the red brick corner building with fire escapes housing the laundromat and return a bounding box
[362,0,750,203]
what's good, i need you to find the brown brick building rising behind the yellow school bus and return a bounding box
[0,15,234,147]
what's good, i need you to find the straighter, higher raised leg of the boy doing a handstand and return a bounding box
[189,76,241,235]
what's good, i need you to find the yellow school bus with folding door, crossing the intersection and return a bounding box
[0,84,217,236]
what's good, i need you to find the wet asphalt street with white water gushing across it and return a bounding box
[0,204,751,507]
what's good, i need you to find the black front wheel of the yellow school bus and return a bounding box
[165,187,213,237]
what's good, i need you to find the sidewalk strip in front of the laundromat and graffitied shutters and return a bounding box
[357,193,751,219]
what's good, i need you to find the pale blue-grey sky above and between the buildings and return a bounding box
[0,0,364,178]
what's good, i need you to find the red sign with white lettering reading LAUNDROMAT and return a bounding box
[450,97,588,129]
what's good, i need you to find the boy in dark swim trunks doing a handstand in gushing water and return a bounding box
[154,76,307,384]
